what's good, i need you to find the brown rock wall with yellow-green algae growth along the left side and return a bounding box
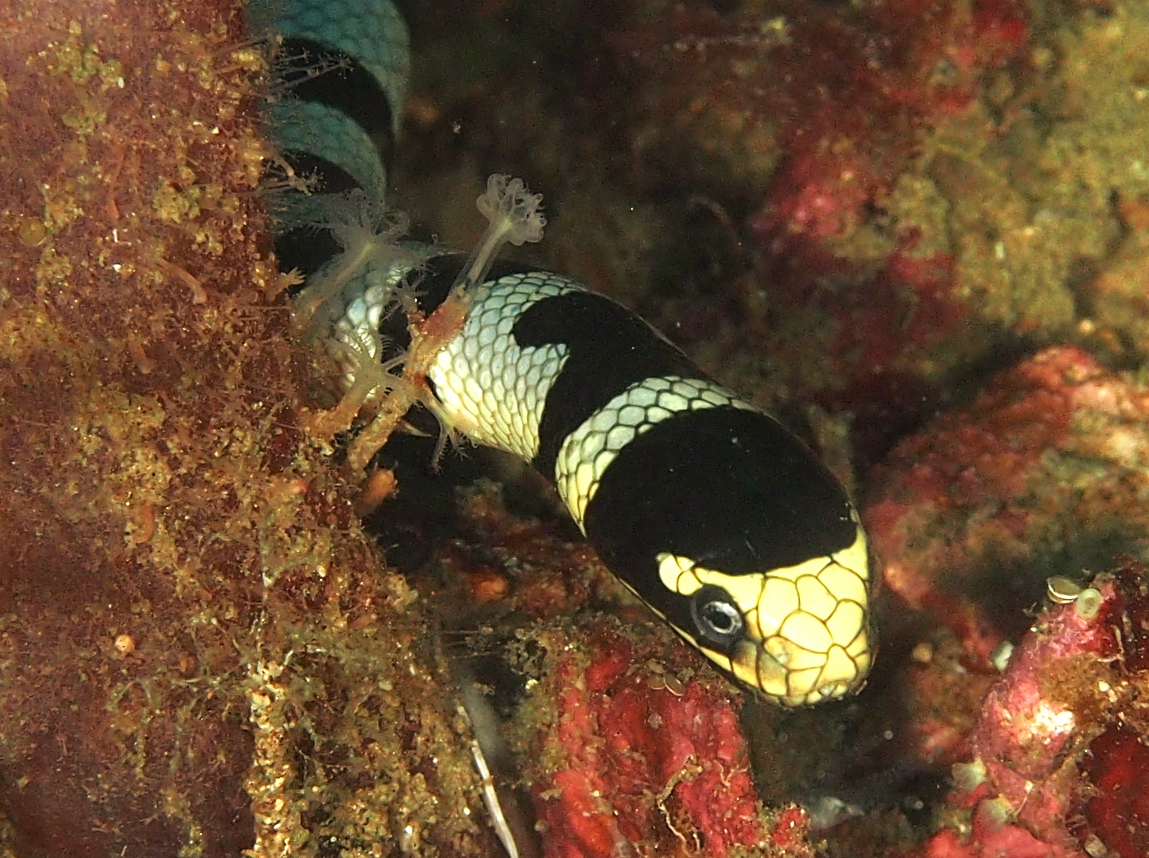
[0,0,493,858]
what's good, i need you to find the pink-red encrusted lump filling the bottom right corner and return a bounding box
[917,564,1149,858]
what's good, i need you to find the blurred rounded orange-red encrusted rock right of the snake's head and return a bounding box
[865,347,1149,668]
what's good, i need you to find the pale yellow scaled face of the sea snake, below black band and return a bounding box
[657,523,872,706]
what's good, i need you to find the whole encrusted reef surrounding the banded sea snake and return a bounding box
[0,0,1149,858]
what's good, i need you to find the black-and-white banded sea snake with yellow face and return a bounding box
[252,0,873,706]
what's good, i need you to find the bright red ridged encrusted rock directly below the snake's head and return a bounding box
[523,631,776,858]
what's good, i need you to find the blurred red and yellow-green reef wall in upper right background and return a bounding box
[588,2,1149,461]
